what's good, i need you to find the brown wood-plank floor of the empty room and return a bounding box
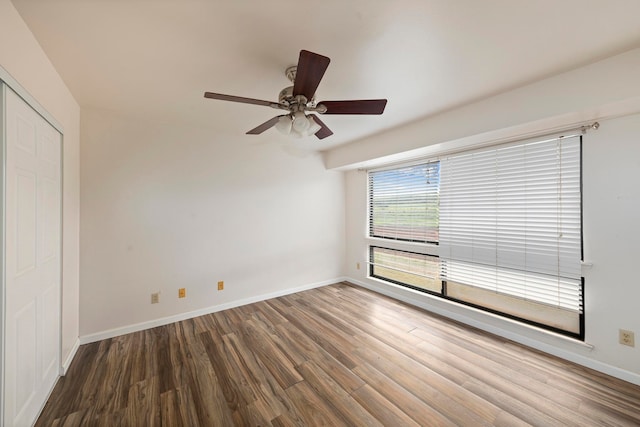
[36,283,640,426]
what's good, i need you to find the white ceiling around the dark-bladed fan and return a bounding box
[8,0,640,150]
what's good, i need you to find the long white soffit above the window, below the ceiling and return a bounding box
[325,48,640,169]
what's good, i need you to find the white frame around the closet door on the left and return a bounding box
[0,65,64,425]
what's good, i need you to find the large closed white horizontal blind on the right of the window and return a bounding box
[440,136,582,313]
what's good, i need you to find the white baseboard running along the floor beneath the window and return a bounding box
[345,277,640,385]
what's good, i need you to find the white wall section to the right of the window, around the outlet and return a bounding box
[583,114,640,377]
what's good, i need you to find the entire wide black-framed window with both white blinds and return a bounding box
[369,136,584,337]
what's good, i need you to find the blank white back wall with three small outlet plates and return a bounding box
[80,109,345,342]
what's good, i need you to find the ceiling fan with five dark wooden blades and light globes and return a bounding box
[204,50,387,139]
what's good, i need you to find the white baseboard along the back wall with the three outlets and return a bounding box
[80,277,346,344]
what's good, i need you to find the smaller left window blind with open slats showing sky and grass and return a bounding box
[369,162,439,242]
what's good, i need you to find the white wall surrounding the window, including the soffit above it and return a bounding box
[338,50,640,384]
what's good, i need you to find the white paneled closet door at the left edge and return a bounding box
[4,90,61,426]
